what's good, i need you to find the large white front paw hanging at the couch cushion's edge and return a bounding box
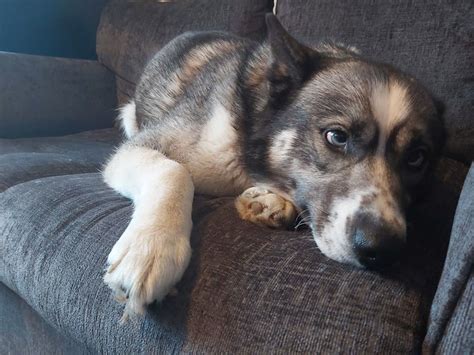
[104,222,191,321]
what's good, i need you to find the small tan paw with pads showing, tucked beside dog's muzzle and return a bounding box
[235,187,296,228]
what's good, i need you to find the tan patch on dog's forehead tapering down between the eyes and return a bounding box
[370,79,411,152]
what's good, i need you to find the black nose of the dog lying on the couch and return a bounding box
[353,216,405,269]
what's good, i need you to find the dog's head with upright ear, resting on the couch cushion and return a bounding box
[267,15,444,267]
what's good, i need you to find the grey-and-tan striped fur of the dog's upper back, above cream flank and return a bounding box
[119,32,251,138]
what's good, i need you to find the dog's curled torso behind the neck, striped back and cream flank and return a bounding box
[119,32,258,195]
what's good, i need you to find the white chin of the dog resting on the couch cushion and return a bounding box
[311,227,364,268]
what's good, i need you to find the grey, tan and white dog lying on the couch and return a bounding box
[104,14,444,317]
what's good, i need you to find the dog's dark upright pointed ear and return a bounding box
[265,13,319,103]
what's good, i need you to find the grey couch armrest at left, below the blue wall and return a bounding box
[0,52,116,138]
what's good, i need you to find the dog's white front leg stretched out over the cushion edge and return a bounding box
[104,145,194,320]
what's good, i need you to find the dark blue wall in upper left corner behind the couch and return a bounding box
[0,0,106,59]
